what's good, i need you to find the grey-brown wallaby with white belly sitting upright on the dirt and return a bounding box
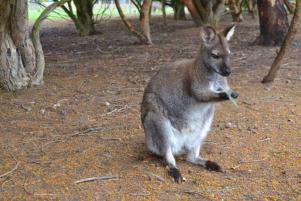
[141,25,238,183]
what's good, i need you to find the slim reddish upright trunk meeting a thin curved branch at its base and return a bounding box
[140,0,152,44]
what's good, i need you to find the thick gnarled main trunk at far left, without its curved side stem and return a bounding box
[0,0,31,91]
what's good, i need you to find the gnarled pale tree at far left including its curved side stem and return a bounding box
[0,0,69,91]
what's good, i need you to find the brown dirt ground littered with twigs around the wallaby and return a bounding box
[0,15,301,201]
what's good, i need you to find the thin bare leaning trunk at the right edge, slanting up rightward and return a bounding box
[262,0,301,83]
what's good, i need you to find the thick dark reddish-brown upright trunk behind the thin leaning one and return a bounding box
[257,0,289,46]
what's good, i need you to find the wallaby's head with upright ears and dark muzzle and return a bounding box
[200,25,235,77]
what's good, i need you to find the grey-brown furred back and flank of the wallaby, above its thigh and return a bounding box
[141,59,195,122]
